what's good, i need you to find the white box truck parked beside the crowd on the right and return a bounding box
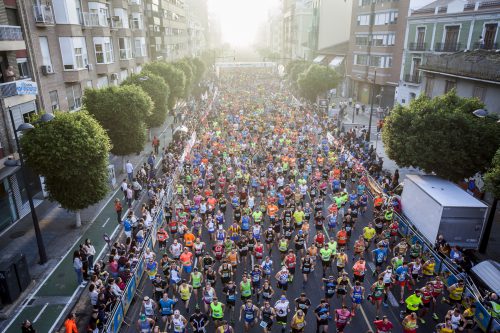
[401,175,488,249]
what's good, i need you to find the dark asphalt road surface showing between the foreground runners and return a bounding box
[121,156,458,333]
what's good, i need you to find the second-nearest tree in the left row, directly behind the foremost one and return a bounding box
[83,85,153,156]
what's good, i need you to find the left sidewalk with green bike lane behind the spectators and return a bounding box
[0,116,173,332]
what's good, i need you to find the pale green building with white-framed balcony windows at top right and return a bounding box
[397,0,500,104]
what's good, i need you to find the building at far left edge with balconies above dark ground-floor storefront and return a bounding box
[0,0,43,230]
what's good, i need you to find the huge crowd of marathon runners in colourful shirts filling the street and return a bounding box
[82,70,480,333]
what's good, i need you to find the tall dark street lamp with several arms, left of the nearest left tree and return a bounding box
[4,107,54,265]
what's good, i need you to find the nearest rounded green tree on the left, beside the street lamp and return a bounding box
[21,111,111,227]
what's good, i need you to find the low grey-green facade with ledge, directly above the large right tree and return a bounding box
[418,49,500,115]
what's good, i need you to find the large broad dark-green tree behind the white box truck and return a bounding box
[382,91,500,181]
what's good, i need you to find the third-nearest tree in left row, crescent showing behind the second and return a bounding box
[122,71,170,128]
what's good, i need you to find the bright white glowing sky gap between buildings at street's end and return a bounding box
[209,0,279,46]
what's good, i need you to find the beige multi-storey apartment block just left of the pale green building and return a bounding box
[346,0,409,107]
